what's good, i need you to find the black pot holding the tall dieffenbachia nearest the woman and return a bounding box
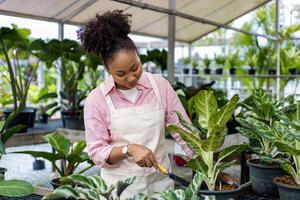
[199,186,242,200]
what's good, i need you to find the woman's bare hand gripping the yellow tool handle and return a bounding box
[128,144,158,169]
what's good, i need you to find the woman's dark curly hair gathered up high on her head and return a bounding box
[77,10,136,64]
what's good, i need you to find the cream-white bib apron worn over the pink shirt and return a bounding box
[100,72,174,199]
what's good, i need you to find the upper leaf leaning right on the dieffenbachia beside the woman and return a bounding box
[208,95,239,134]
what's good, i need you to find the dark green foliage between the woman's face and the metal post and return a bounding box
[140,49,168,71]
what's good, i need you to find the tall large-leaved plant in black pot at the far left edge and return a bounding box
[0,25,43,132]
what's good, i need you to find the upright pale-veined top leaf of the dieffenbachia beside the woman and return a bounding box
[194,90,218,129]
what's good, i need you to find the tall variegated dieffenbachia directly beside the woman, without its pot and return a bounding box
[167,90,247,190]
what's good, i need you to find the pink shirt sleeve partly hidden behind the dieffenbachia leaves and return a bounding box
[165,82,194,158]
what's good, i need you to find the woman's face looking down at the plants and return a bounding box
[107,50,143,90]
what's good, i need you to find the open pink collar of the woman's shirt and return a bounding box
[104,72,152,95]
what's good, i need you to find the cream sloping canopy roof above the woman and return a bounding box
[0,0,270,43]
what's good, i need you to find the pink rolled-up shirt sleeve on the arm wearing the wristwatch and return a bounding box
[84,98,118,168]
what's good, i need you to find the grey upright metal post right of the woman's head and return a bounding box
[167,0,176,83]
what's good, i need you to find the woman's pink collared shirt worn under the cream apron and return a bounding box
[84,72,193,167]
